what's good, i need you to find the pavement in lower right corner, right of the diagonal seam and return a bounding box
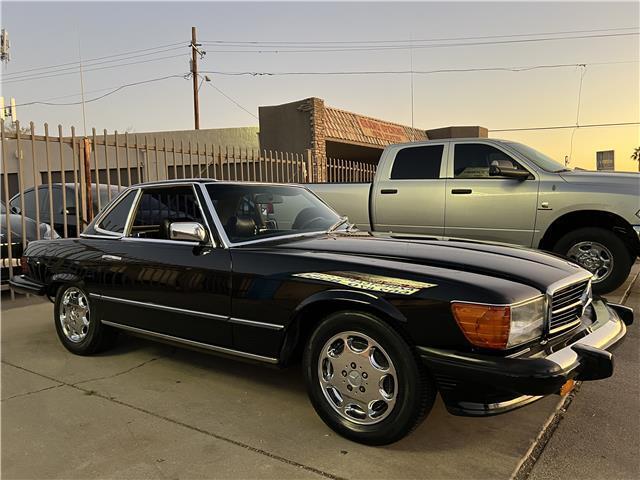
[529,270,640,480]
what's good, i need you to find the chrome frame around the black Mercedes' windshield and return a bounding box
[199,181,349,248]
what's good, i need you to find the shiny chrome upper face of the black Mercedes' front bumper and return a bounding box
[546,300,627,371]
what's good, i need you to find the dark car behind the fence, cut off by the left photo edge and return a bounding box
[0,202,59,285]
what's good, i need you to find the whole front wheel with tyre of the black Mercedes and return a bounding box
[304,311,436,445]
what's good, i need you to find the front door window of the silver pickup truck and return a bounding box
[453,143,526,178]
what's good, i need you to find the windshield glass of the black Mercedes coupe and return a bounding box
[207,183,347,243]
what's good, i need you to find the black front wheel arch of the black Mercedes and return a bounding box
[280,290,407,365]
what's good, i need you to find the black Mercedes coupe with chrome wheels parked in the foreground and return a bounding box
[11,180,633,444]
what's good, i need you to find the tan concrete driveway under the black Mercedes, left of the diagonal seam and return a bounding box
[1,270,640,479]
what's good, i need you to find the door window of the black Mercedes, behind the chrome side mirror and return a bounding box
[129,186,204,240]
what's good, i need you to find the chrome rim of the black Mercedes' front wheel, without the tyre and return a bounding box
[318,331,398,425]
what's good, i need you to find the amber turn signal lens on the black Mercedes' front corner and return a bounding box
[451,302,511,348]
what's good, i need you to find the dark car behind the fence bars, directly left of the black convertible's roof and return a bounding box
[9,183,118,237]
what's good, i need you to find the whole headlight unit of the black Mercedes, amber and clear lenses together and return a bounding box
[451,295,546,349]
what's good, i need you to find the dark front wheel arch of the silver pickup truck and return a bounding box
[538,210,640,256]
